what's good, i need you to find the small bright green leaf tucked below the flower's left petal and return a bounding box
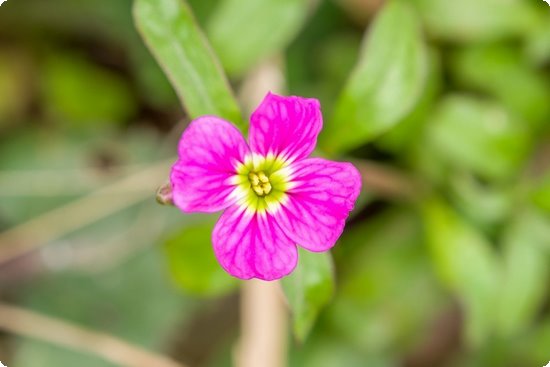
[165,221,237,296]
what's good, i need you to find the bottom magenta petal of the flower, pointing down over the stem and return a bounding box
[212,205,298,280]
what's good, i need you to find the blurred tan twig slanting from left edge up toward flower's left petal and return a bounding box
[0,159,173,264]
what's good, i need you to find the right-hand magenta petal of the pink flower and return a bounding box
[275,158,361,252]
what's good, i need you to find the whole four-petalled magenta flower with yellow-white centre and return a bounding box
[170,93,361,280]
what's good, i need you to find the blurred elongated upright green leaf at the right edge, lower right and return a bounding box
[498,210,550,336]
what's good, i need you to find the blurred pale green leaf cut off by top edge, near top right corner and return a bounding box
[412,0,543,42]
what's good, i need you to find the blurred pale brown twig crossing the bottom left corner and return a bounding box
[0,303,184,367]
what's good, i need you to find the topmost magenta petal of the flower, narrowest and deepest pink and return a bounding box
[248,93,323,162]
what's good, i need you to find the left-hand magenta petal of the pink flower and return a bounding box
[170,116,250,213]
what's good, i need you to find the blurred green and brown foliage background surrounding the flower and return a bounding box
[0,0,550,367]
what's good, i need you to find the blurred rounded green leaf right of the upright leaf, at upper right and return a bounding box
[428,95,531,179]
